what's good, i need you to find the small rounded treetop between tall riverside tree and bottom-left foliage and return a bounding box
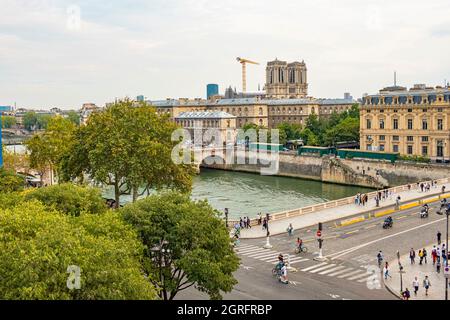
[24,183,107,216]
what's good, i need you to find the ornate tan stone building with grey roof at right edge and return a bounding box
[360,84,450,162]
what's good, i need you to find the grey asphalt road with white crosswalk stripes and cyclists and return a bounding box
[178,198,445,300]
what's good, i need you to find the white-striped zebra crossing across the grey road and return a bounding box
[235,244,374,283]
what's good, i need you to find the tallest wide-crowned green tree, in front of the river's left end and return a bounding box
[64,99,195,207]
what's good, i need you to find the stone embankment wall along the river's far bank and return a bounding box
[201,152,450,188]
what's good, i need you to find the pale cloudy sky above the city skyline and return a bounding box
[0,0,450,109]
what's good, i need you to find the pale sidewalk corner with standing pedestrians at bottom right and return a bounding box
[383,243,450,300]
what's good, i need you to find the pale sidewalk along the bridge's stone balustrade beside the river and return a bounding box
[237,183,450,239]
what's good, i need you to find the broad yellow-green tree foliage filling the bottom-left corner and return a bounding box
[0,201,157,300]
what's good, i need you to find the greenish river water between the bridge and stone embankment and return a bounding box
[192,168,373,218]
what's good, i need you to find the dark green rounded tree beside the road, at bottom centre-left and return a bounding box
[121,192,239,300]
